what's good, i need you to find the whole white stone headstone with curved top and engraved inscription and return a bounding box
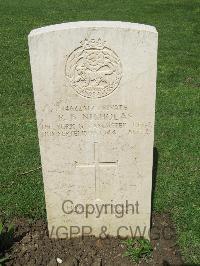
[29,21,157,238]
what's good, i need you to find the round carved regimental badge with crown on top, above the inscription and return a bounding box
[65,39,122,98]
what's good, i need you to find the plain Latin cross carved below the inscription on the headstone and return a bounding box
[75,142,118,194]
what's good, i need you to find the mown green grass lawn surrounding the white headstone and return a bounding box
[0,0,200,265]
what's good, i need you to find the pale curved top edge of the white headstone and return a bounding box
[29,21,157,37]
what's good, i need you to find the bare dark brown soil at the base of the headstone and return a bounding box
[1,213,183,266]
